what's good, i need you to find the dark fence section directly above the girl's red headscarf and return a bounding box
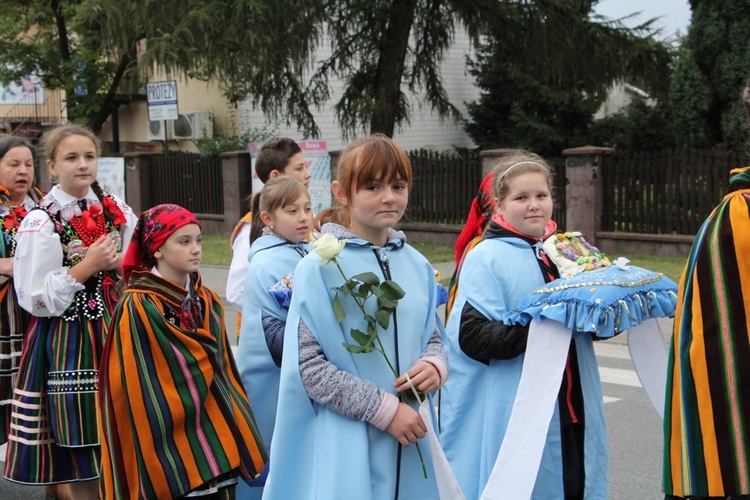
[149,152,224,215]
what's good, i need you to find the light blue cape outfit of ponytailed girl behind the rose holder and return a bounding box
[237,235,310,498]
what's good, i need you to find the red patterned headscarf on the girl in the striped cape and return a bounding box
[122,204,201,283]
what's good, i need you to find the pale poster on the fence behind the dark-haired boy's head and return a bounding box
[247,140,332,214]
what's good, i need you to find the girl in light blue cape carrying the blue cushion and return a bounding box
[440,153,607,500]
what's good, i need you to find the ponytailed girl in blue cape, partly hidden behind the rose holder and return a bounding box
[237,176,313,498]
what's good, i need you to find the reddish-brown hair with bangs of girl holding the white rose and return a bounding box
[317,134,412,227]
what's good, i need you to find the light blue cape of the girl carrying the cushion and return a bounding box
[440,238,607,499]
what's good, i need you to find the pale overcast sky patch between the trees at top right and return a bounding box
[594,0,691,38]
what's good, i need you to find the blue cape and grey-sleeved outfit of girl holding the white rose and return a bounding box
[263,223,447,500]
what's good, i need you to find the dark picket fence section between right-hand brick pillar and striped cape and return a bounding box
[602,147,748,235]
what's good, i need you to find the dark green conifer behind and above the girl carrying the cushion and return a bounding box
[466,0,670,154]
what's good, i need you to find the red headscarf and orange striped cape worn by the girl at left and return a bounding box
[99,205,266,498]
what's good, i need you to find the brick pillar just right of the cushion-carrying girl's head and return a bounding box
[561,146,615,245]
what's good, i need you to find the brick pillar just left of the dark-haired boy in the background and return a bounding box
[221,151,252,235]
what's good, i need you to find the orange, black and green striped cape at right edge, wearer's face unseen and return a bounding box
[663,167,750,497]
